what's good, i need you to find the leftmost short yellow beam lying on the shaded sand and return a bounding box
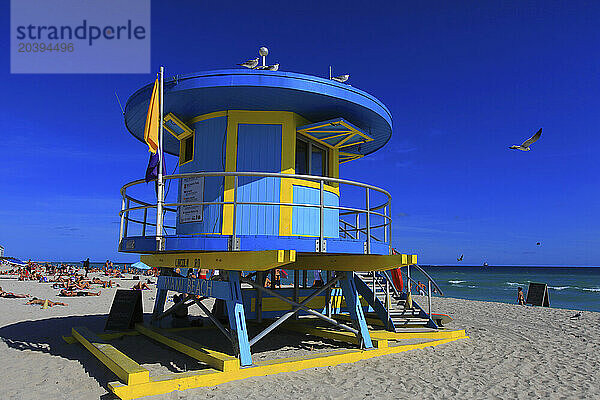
[71,327,150,385]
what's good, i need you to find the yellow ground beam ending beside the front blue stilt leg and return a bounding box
[135,324,240,372]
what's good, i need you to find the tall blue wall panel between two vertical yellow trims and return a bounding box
[236,124,281,235]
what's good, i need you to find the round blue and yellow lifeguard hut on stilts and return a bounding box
[68,49,464,398]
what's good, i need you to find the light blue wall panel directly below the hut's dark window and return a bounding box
[292,185,340,238]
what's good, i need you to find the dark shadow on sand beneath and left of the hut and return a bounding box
[0,314,340,400]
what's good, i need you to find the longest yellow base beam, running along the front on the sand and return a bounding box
[108,336,468,400]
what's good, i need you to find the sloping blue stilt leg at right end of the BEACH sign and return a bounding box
[226,271,252,366]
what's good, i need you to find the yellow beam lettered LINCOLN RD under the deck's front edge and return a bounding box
[140,250,296,271]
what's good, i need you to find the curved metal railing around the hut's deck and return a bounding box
[119,172,392,253]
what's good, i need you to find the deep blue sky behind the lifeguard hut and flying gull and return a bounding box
[0,1,600,265]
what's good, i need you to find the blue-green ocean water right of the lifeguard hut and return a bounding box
[418,266,600,311]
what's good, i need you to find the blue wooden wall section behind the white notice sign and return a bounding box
[177,117,227,234]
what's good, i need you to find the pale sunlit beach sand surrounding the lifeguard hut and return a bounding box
[0,277,600,400]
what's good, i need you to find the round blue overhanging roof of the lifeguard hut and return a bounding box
[125,69,392,155]
